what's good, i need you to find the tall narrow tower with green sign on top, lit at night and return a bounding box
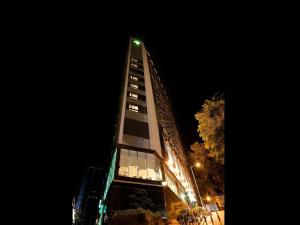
[99,38,197,224]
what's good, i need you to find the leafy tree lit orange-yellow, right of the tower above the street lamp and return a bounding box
[195,95,225,165]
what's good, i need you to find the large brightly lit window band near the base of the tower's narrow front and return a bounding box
[119,149,162,181]
